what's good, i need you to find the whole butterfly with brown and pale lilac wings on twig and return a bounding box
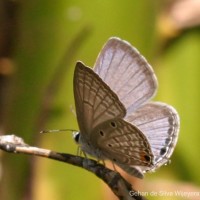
[73,37,180,178]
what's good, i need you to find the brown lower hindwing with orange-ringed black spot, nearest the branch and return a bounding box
[91,118,153,178]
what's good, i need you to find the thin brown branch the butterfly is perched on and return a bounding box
[0,135,145,200]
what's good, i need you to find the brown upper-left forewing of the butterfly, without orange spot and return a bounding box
[74,62,126,135]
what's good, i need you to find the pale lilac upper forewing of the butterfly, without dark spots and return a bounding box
[94,37,157,114]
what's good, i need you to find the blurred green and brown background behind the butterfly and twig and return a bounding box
[0,0,200,200]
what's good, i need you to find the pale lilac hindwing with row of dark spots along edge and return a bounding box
[125,102,180,170]
